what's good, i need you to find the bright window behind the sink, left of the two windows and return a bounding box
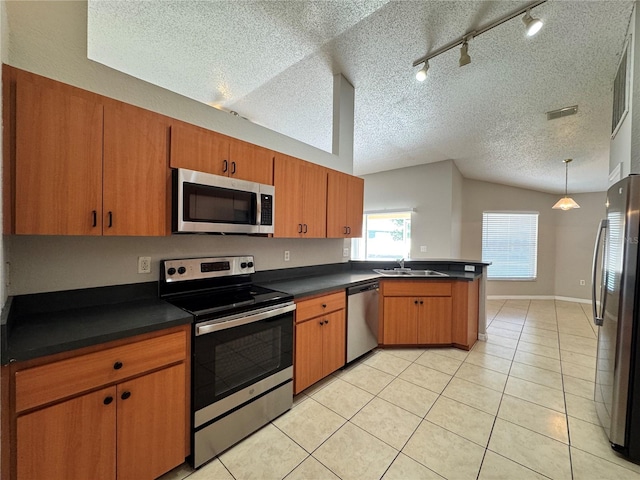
[351,212,411,260]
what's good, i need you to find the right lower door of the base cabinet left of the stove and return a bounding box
[117,363,187,480]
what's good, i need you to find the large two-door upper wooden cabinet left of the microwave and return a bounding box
[3,66,170,236]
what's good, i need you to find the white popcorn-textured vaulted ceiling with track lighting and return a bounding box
[89,0,633,193]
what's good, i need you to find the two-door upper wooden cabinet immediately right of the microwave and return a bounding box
[273,154,328,238]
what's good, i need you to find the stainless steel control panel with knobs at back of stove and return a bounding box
[161,255,256,283]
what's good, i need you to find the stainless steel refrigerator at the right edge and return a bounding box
[592,175,640,461]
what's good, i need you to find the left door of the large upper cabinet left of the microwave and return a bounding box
[15,74,102,235]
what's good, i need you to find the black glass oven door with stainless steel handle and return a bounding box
[192,302,296,428]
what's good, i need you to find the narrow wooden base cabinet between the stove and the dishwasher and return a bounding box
[294,291,346,394]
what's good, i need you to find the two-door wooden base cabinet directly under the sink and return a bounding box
[382,280,453,345]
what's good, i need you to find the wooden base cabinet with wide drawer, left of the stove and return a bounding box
[3,326,189,480]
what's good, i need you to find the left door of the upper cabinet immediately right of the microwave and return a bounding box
[273,154,304,238]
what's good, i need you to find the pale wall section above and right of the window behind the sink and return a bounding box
[363,160,460,258]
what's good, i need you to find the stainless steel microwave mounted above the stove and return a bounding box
[172,168,275,233]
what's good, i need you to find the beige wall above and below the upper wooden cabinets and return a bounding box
[0,1,352,298]
